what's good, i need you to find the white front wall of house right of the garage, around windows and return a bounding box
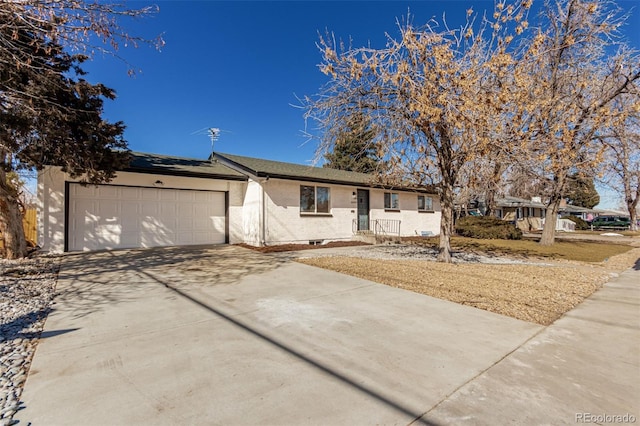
[258,179,440,245]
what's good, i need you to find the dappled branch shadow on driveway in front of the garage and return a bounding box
[56,245,287,318]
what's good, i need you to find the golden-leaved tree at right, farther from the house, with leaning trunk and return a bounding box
[511,0,640,245]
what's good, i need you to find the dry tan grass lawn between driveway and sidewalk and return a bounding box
[298,243,640,325]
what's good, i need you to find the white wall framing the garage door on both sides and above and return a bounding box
[38,167,246,252]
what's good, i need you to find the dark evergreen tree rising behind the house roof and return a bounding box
[324,114,382,173]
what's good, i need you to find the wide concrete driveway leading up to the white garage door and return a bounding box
[16,246,542,425]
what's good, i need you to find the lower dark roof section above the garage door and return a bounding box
[124,152,247,180]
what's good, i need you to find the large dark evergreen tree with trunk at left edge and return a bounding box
[0,7,129,258]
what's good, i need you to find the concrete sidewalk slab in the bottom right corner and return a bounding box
[425,261,640,425]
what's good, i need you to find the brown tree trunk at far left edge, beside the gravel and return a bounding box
[0,167,27,259]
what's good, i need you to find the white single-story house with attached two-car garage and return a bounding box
[38,153,440,252]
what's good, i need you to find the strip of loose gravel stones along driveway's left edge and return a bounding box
[0,256,59,426]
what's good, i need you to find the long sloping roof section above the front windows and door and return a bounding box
[212,152,433,192]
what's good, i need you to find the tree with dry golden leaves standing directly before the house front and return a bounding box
[305,5,531,262]
